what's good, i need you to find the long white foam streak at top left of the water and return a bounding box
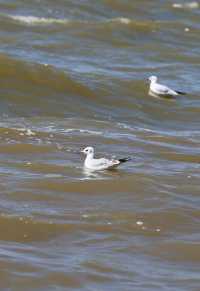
[8,15,69,25]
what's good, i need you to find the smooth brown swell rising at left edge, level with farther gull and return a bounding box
[0,54,94,97]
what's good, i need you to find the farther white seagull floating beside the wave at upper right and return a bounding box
[148,76,186,97]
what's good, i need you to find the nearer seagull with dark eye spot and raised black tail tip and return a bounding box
[81,147,130,171]
